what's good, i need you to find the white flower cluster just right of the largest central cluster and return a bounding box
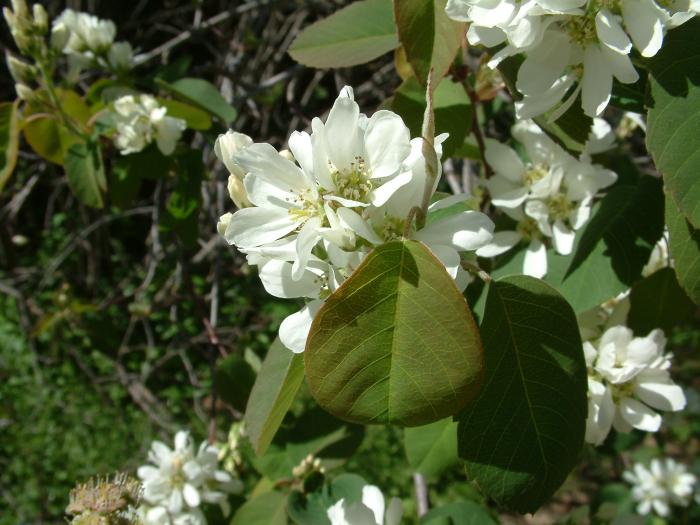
[477,119,617,278]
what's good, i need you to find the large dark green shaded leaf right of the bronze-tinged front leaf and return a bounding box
[458,276,587,513]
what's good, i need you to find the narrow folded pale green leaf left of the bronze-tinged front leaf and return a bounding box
[243,339,304,455]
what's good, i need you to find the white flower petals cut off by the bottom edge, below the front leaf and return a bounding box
[326,485,403,525]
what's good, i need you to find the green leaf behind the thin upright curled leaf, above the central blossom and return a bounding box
[391,77,472,158]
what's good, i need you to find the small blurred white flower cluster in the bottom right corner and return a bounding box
[623,458,697,517]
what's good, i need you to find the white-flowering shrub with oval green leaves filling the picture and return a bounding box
[0,0,700,525]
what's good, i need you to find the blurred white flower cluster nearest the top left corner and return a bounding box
[51,9,134,71]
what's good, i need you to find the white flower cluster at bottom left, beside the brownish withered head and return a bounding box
[138,431,242,525]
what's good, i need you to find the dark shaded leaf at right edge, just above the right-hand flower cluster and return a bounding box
[627,268,695,336]
